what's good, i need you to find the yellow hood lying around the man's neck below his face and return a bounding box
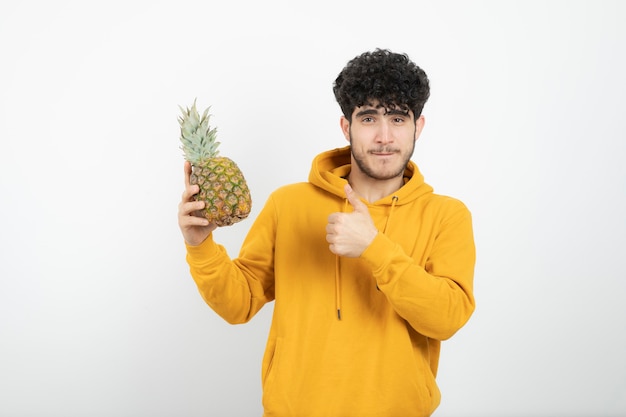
[309,146,433,206]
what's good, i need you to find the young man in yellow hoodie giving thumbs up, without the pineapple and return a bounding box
[178,49,475,417]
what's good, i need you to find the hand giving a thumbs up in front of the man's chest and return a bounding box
[326,184,378,258]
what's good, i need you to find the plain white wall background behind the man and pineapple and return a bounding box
[0,0,626,417]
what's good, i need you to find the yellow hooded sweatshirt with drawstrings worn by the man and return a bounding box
[187,148,475,417]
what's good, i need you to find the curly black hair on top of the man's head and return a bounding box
[333,49,430,120]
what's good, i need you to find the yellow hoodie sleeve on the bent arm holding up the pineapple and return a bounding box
[186,194,275,324]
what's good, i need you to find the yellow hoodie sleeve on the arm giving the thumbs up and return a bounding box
[361,202,476,340]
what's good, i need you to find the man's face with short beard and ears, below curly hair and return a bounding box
[341,105,424,180]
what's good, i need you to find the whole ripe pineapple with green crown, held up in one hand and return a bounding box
[178,100,252,226]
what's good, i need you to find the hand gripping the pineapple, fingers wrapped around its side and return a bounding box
[178,161,217,246]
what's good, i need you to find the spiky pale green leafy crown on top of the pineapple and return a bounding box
[178,100,220,165]
